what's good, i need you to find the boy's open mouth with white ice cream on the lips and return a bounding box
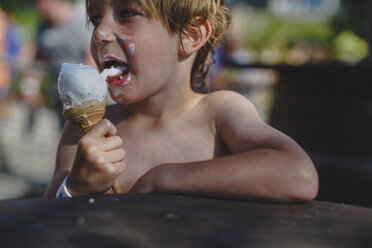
[101,60,131,86]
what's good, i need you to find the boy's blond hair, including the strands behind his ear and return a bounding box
[86,0,231,91]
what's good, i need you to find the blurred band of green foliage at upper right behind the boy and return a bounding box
[231,2,368,64]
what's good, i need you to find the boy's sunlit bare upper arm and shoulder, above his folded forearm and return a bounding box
[206,91,286,153]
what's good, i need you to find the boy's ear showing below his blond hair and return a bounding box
[178,17,212,56]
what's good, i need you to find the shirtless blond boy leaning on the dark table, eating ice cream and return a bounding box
[46,0,318,202]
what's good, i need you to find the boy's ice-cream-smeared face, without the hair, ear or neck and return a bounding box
[88,0,178,103]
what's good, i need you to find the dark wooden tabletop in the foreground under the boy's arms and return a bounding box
[0,194,372,248]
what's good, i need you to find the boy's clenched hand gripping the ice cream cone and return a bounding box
[67,119,126,196]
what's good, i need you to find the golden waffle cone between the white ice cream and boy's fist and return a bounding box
[63,100,106,133]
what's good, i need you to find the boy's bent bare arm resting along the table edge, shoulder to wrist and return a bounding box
[131,92,318,202]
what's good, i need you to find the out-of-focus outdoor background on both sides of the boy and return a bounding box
[0,0,372,207]
